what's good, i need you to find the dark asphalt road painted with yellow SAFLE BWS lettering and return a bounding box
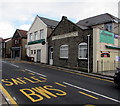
[2,61,120,106]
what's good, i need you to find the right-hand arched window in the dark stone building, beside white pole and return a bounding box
[78,43,87,59]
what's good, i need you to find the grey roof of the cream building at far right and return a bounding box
[77,13,120,26]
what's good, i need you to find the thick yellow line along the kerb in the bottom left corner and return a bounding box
[0,84,18,106]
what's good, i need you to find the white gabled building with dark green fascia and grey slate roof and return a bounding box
[27,15,58,63]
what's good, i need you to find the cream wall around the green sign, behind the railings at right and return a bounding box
[93,28,119,73]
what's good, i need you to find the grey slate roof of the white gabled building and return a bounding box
[38,16,59,27]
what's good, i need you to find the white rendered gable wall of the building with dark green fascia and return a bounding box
[27,16,47,63]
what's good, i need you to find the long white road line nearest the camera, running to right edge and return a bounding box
[63,82,120,103]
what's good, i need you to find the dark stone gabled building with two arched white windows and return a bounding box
[48,16,93,70]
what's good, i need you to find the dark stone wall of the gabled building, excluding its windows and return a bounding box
[48,17,93,71]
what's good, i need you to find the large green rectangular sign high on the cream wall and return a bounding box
[100,30,114,44]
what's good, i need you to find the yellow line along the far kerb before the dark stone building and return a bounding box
[48,67,114,83]
